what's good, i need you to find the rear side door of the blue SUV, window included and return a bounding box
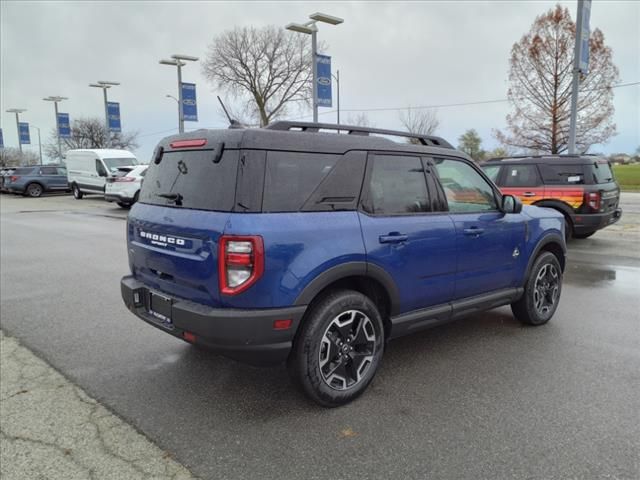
[359,154,456,313]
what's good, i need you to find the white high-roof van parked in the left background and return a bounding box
[65,149,138,200]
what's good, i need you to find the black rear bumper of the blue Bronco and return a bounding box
[120,276,307,365]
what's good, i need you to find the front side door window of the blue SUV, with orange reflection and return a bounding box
[435,158,498,213]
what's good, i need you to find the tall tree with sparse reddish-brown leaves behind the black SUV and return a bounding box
[496,5,619,153]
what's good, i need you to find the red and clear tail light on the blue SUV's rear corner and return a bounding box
[218,235,264,295]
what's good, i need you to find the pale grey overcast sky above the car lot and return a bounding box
[0,0,640,161]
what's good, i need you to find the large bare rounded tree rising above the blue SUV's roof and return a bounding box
[202,26,311,126]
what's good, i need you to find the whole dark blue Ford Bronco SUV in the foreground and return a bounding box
[121,122,565,406]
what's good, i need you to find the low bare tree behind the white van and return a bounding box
[44,118,138,160]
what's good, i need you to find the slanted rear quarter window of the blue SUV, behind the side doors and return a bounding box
[262,152,341,212]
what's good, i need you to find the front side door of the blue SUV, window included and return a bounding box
[433,158,524,299]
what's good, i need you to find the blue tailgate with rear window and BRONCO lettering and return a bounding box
[128,149,238,306]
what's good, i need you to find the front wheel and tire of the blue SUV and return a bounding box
[511,252,562,325]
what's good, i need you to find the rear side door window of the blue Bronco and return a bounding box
[366,155,429,215]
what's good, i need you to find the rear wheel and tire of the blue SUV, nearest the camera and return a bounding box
[287,290,384,407]
